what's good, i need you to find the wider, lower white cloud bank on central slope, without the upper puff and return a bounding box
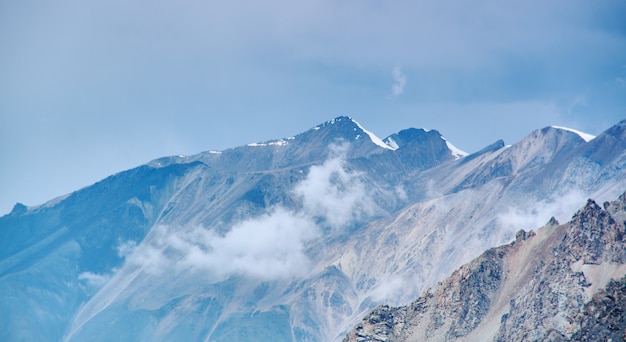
[129,208,319,281]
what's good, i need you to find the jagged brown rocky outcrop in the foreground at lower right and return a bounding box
[344,193,626,342]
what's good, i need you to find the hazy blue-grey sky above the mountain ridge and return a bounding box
[0,0,626,215]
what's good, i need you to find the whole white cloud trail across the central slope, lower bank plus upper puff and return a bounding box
[125,147,374,282]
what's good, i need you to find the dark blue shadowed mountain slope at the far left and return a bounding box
[0,163,201,341]
